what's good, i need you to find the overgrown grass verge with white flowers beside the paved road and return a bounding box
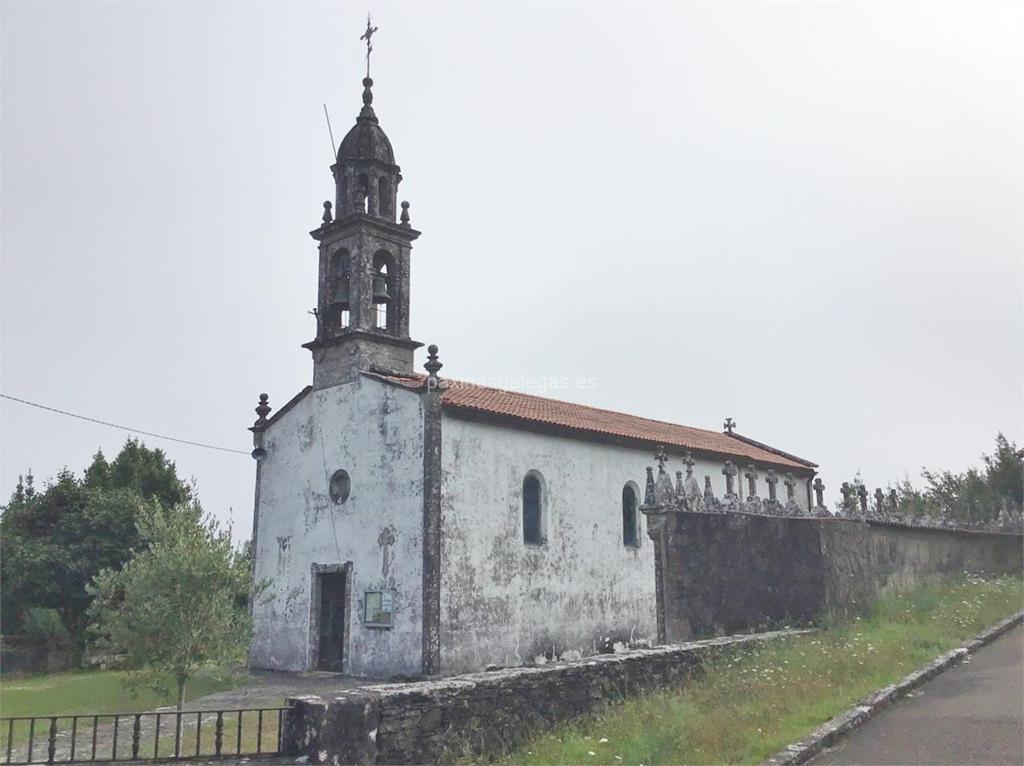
[491,577,1024,766]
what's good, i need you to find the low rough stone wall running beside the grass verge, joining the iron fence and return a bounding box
[284,631,795,764]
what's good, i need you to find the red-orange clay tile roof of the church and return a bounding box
[368,373,817,470]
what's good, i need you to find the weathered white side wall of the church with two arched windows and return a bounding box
[440,414,794,673]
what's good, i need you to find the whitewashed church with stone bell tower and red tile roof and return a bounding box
[250,62,820,678]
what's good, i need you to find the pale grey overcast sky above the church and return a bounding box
[0,2,1024,538]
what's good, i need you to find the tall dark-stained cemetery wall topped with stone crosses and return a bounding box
[648,511,1024,642]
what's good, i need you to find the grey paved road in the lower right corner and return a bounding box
[812,627,1024,766]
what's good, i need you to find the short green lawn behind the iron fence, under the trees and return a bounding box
[0,671,233,718]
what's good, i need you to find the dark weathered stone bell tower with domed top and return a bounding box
[303,76,423,388]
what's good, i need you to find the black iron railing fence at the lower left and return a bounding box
[0,708,290,765]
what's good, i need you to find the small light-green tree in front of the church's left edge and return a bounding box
[89,501,256,710]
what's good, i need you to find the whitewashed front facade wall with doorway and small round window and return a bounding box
[251,378,423,676]
